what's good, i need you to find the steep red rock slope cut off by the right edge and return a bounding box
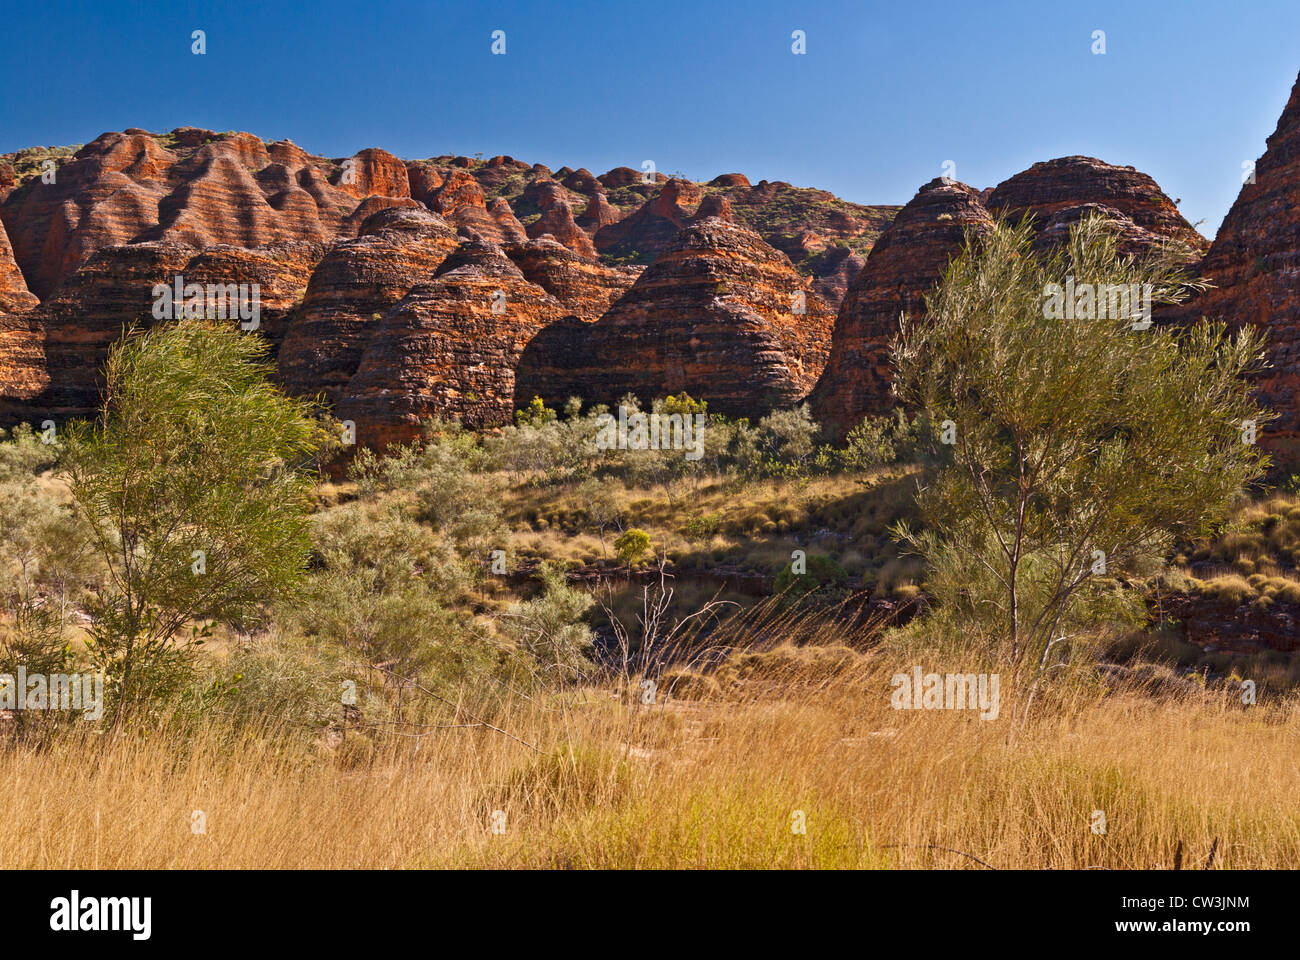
[1156,70,1300,452]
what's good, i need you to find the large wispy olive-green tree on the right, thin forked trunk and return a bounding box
[894,217,1271,671]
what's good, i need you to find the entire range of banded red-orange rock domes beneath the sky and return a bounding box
[0,119,1263,445]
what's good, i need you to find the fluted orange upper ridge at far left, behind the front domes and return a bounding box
[0,127,411,299]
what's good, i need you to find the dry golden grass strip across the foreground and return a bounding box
[0,647,1300,869]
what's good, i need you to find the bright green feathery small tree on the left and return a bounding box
[62,320,330,708]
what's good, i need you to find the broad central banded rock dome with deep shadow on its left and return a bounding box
[516,217,832,416]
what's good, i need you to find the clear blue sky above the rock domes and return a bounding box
[0,0,1300,235]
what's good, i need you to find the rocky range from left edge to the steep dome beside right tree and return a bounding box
[0,127,896,444]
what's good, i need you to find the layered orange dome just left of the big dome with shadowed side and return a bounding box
[338,241,562,447]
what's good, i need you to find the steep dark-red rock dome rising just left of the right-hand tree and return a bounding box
[809,177,993,440]
